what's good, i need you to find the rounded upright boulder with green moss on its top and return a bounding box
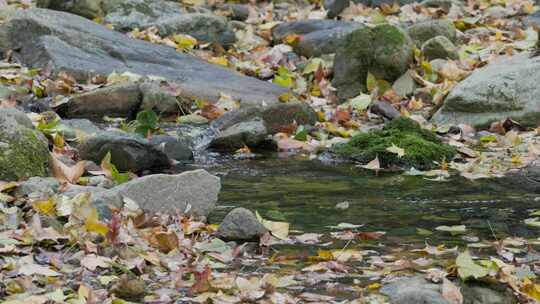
[332,24,414,100]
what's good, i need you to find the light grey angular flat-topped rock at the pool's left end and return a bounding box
[93,170,221,217]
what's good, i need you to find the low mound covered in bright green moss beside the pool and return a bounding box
[336,117,456,170]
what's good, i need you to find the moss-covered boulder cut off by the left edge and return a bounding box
[0,108,50,181]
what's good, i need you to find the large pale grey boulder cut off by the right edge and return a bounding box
[432,53,540,127]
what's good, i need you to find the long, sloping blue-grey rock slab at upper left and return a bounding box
[0,9,286,106]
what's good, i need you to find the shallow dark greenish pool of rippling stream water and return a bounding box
[192,157,540,245]
